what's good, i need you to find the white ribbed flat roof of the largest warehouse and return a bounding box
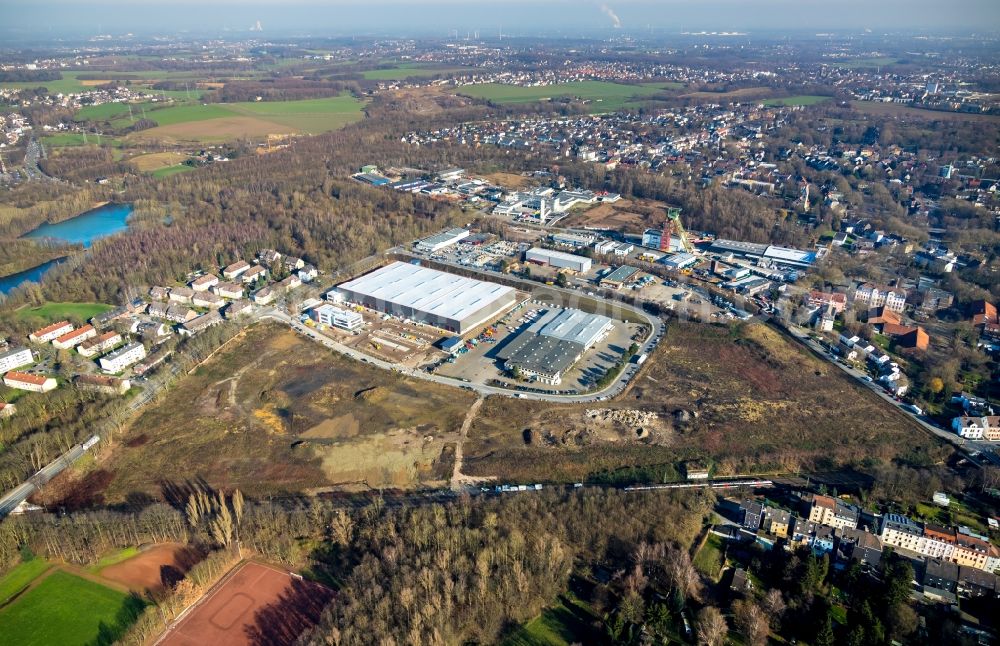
[339,262,514,321]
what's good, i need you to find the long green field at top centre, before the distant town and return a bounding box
[458,81,664,112]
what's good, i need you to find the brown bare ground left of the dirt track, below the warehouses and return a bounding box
[85,324,474,506]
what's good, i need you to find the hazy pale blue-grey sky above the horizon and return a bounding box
[0,0,1000,40]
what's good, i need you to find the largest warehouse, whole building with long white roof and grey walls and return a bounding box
[337,262,516,334]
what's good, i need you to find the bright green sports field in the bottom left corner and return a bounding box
[0,571,143,646]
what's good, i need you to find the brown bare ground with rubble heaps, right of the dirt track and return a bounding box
[462,322,947,482]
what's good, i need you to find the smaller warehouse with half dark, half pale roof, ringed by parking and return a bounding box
[497,308,614,386]
